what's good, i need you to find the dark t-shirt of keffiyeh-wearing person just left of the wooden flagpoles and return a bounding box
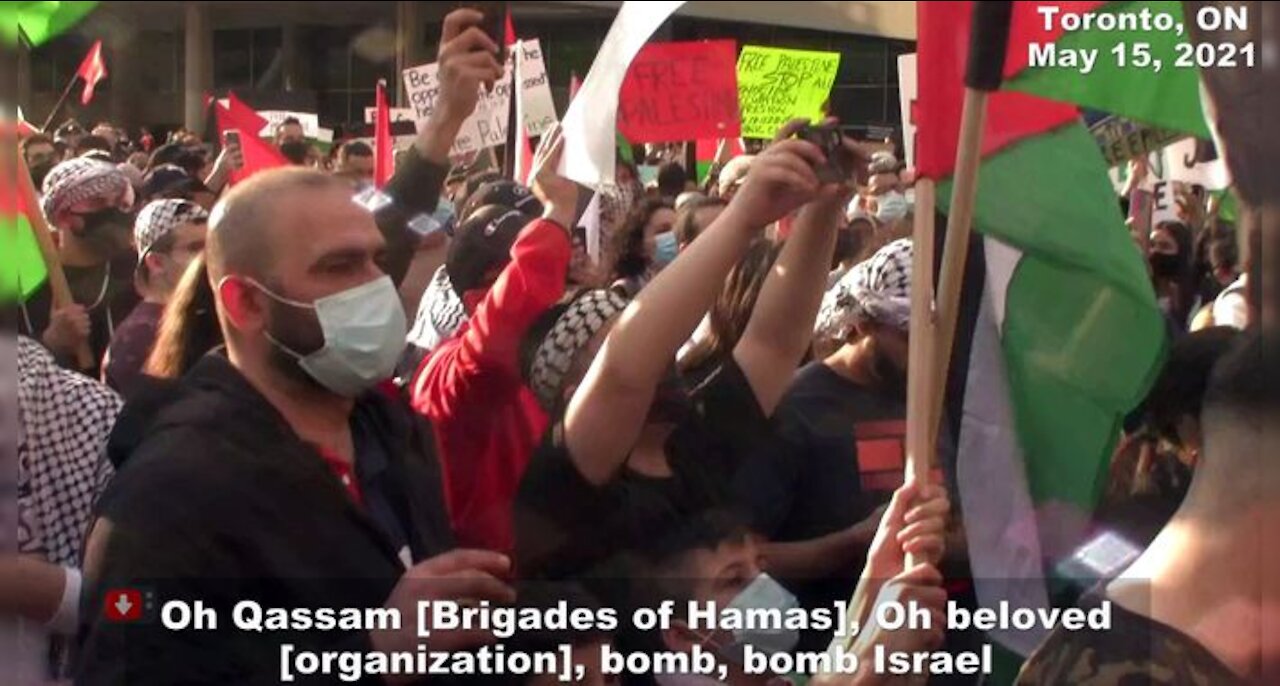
[733,362,906,642]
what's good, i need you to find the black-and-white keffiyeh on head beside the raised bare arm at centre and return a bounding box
[525,289,627,408]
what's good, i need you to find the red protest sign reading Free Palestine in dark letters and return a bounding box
[618,41,742,143]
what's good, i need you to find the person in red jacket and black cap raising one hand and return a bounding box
[410,126,577,550]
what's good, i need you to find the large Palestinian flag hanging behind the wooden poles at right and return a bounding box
[916,1,1165,655]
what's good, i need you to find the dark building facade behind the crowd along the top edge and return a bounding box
[19,1,914,142]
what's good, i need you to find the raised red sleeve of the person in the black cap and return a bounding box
[412,219,572,411]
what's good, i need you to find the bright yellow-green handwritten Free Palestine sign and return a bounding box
[737,45,840,138]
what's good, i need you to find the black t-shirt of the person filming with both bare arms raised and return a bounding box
[515,358,771,594]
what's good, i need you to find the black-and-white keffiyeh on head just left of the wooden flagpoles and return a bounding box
[813,238,911,340]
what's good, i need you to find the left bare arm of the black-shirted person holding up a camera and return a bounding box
[564,127,823,484]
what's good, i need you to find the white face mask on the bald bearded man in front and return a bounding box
[255,275,406,398]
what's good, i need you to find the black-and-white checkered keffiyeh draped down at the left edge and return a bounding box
[18,337,124,568]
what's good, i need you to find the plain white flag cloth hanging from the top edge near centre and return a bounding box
[559,0,685,188]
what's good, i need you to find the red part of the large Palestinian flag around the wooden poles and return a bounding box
[913,3,1097,178]
